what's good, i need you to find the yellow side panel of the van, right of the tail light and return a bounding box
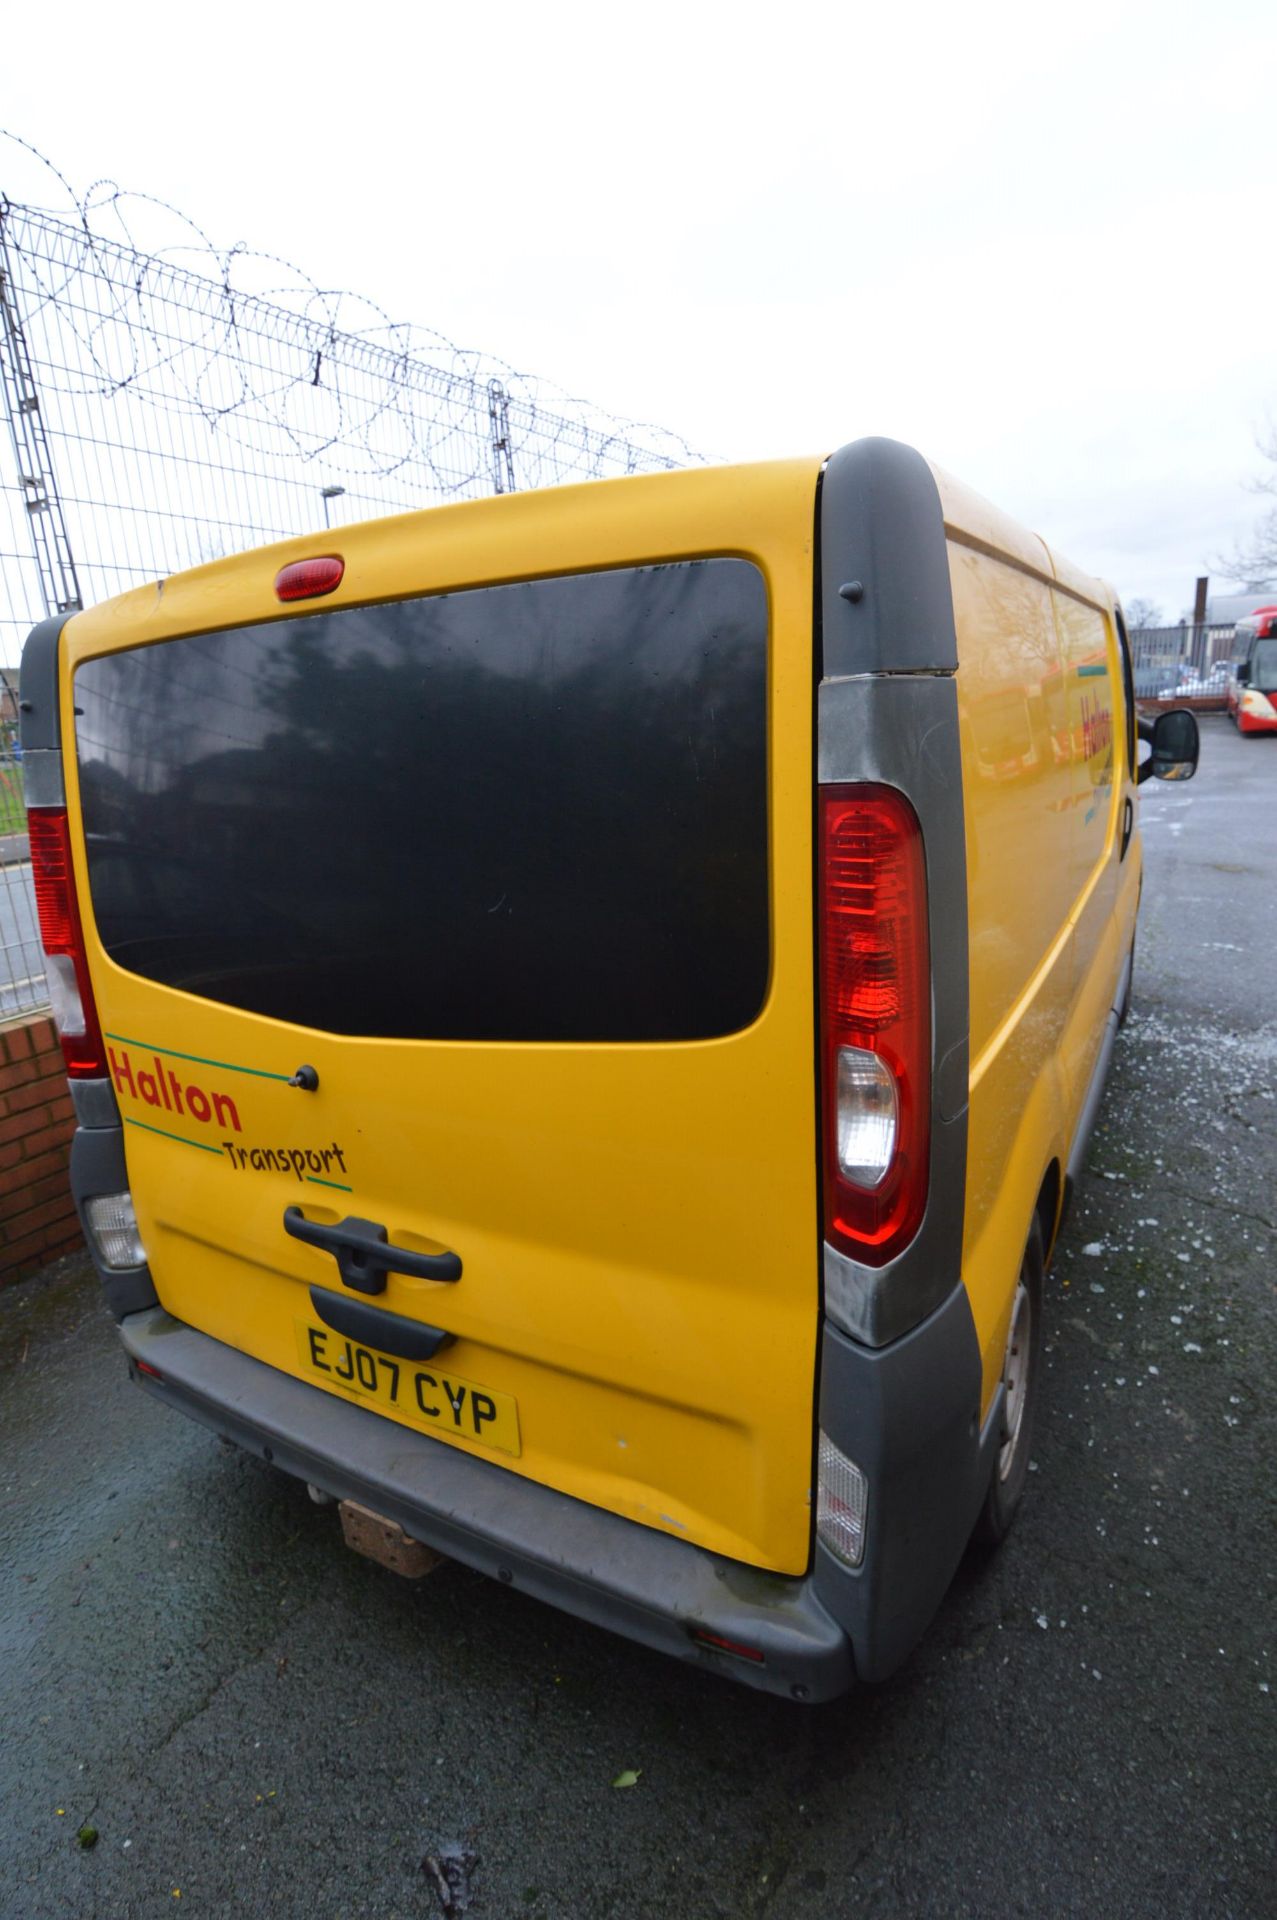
[933,456,1141,1409]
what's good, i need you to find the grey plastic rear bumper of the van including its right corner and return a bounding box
[119,1286,1000,1701]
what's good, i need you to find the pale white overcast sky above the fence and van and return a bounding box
[0,0,1277,616]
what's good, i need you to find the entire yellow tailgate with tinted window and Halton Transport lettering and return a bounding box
[63,463,818,1572]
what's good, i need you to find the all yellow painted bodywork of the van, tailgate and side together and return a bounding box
[63,459,1139,1572]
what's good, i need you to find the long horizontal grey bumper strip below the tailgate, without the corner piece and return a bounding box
[119,1308,853,1701]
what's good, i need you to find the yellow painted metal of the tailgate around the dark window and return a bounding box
[63,459,820,1572]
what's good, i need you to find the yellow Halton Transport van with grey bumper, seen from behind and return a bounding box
[23,440,1196,1701]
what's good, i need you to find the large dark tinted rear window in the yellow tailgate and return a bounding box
[75,559,770,1041]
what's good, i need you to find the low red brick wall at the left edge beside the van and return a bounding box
[0,1014,81,1286]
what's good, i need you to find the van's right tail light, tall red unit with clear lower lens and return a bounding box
[820,785,931,1267]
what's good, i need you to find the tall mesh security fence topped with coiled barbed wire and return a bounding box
[0,134,701,1018]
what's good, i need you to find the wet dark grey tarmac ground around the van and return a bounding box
[0,720,1277,1920]
